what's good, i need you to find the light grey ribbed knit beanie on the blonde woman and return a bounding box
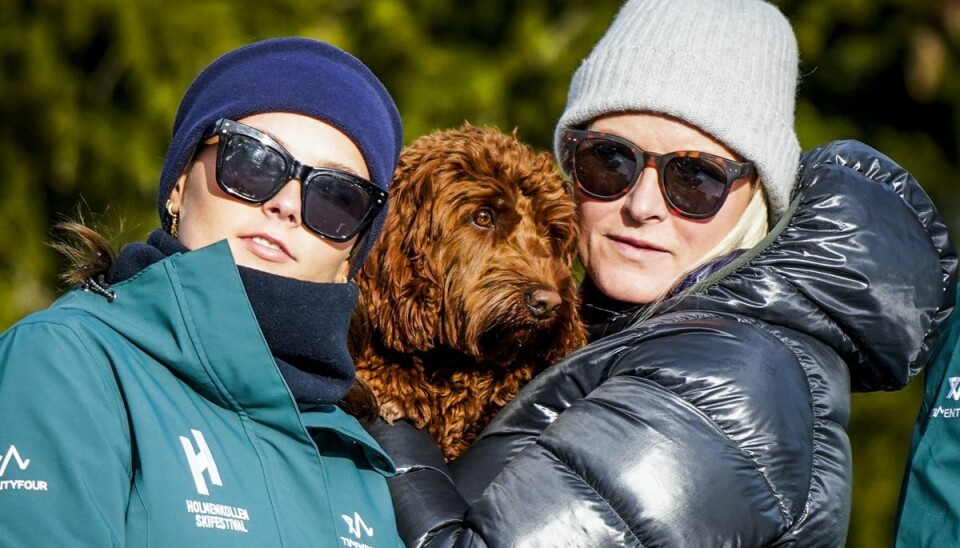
[554,0,800,221]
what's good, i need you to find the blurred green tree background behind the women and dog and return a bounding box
[0,0,960,547]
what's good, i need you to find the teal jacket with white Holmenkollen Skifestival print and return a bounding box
[0,242,402,548]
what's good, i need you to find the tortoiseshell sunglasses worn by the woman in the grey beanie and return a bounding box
[563,129,756,219]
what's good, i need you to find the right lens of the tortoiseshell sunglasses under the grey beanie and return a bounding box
[662,156,727,216]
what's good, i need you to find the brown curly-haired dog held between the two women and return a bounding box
[352,124,586,460]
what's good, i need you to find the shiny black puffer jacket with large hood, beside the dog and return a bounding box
[373,141,956,547]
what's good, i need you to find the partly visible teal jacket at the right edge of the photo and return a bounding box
[896,288,960,548]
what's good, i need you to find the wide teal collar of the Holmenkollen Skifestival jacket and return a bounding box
[61,241,393,473]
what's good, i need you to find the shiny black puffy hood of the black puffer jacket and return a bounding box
[664,141,957,391]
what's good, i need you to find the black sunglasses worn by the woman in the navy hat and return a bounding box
[204,118,387,242]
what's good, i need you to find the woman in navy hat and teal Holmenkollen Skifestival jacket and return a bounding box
[0,38,402,548]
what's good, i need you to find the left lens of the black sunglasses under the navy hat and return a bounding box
[219,135,287,202]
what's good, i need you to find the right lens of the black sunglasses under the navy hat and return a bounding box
[303,175,373,239]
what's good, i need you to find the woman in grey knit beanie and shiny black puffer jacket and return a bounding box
[371,0,956,547]
